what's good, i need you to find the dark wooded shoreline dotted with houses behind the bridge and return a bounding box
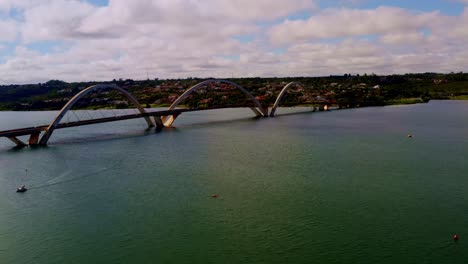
[0,72,468,111]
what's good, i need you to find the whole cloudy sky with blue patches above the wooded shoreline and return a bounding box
[0,0,468,84]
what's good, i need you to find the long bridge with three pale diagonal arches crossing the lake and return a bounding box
[0,79,330,147]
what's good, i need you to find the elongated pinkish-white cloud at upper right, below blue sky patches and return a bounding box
[269,7,438,44]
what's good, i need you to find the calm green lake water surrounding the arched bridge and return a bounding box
[0,101,468,263]
